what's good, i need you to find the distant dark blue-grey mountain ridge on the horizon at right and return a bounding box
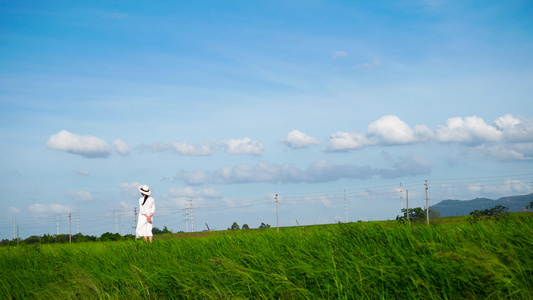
[430,194,533,217]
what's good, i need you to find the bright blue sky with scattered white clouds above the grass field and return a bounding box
[0,0,533,239]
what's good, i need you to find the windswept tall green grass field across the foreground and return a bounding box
[0,214,533,299]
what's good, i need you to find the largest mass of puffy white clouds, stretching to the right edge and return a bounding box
[325,114,533,160]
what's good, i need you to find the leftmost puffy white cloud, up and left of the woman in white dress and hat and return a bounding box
[46,130,111,158]
